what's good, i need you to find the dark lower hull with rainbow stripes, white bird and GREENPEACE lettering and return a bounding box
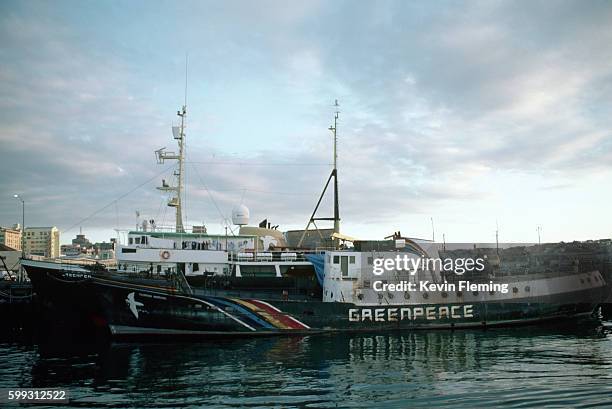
[21,265,603,338]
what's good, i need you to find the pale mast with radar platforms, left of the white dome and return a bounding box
[155,105,187,233]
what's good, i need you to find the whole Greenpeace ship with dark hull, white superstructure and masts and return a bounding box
[22,101,609,339]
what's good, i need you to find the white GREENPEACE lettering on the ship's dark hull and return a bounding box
[348,304,474,322]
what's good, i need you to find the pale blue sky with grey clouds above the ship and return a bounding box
[0,0,612,242]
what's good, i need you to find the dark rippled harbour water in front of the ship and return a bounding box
[0,322,612,408]
